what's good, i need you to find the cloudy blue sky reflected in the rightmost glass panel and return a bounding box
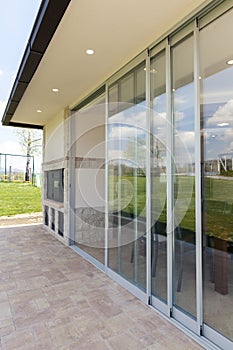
[201,66,233,160]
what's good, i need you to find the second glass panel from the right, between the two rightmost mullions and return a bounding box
[172,36,196,316]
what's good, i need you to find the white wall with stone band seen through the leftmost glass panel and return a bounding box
[73,104,105,208]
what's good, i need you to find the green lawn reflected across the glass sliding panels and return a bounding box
[109,176,233,241]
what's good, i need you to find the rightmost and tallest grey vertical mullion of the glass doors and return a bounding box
[194,21,203,334]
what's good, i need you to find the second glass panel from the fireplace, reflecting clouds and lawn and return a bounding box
[108,65,146,290]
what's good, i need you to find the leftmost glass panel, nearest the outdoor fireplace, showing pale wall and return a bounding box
[72,95,105,264]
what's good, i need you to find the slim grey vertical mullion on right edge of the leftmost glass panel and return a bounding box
[104,85,109,272]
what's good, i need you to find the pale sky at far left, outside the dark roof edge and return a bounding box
[0,0,41,170]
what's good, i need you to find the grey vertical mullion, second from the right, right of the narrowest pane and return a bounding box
[166,42,174,316]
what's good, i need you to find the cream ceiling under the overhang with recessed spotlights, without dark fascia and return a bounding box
[12,0,210,125]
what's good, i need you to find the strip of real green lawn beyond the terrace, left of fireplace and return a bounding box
[0,182,42,216]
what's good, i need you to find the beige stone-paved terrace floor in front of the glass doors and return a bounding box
[0,225,201,350]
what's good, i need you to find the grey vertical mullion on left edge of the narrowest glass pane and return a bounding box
[146,54,151,302]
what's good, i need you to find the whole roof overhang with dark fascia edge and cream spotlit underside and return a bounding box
[2,0,211,128]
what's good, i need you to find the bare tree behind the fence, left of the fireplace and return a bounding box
[16,128,42,181]
